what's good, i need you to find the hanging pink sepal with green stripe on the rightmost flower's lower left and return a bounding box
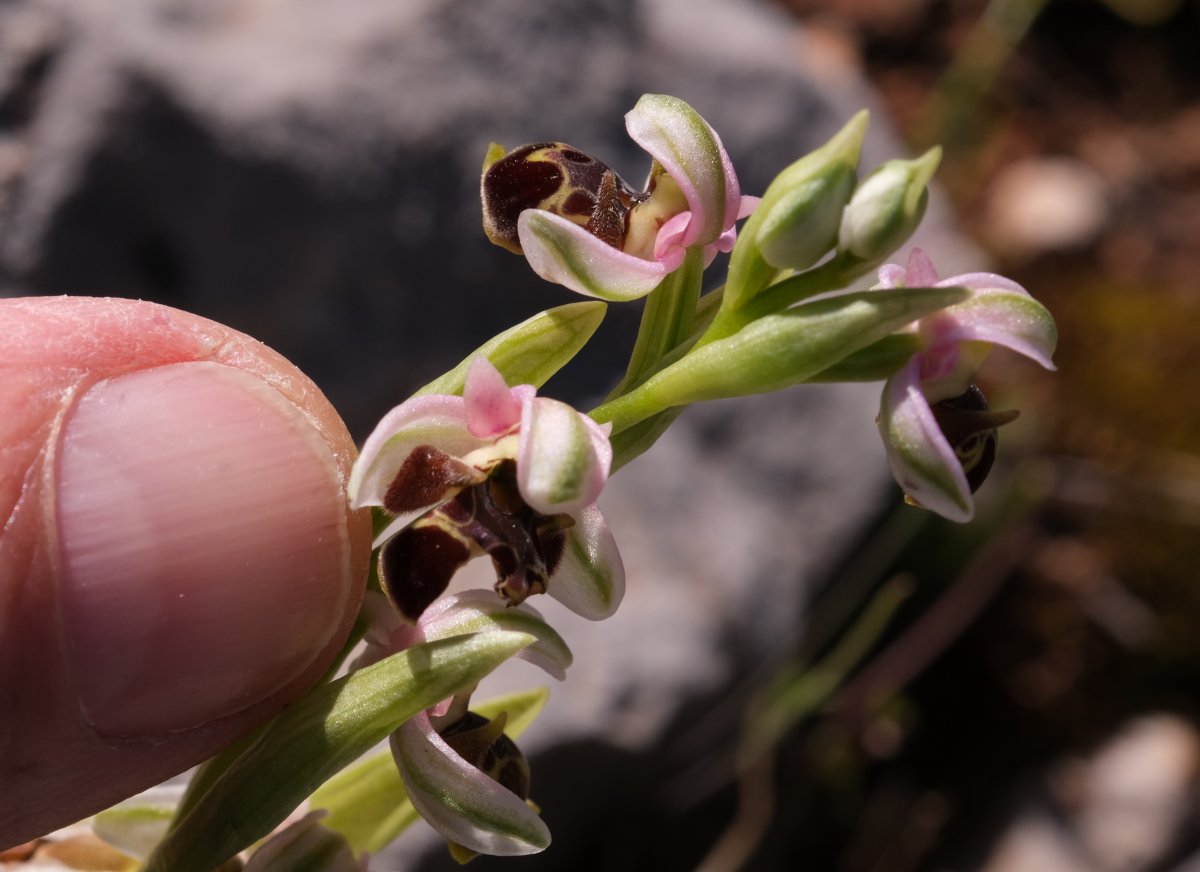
[878,357,974,523]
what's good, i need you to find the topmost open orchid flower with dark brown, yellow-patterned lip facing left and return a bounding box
[481,94,758,301]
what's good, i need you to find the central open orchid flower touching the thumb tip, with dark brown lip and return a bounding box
[348,357,625,621]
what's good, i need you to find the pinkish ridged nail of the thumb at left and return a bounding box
[56,362,350,735]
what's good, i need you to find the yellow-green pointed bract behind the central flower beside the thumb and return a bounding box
[413,300,607,396]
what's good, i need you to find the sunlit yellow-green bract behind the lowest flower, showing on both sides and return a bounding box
[308,687,550,853]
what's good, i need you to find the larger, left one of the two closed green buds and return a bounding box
[744,109,868,270]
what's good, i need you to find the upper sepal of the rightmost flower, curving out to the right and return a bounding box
[940,289,1058,369]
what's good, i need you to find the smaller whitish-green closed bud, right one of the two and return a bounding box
[838,146,942,266]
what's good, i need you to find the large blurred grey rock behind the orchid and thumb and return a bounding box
[0,0,978,868]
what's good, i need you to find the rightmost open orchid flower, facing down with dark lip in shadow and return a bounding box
[876,248,1058,522]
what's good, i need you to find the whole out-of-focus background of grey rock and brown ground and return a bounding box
[0,0,1200,872]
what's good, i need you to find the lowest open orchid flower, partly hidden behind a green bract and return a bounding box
[350,590,571,861]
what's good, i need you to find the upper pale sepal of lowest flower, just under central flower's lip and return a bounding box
[418,590,572,681]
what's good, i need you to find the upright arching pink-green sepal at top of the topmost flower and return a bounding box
[625,94,742,247]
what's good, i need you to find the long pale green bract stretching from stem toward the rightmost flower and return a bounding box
[592,288,967,433]
